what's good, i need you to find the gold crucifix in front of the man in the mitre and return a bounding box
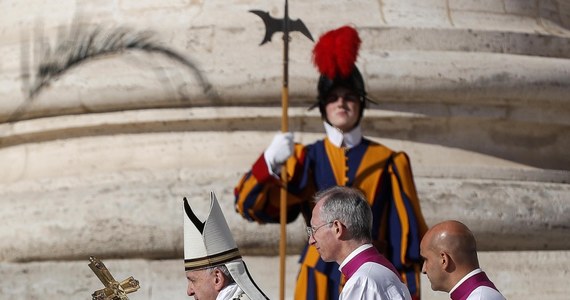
[89,256,140,300]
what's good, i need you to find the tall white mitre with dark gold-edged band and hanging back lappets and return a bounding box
[184,193,268,300]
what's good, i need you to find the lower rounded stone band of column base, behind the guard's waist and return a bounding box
[0,165,570,261]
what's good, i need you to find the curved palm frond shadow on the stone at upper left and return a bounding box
[13,24,218,121]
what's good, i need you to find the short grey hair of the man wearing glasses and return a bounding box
[314,186,372,242]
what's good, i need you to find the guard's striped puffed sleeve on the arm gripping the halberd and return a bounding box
[234,144,310,223]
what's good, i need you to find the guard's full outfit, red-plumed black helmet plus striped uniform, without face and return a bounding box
[235,26,427,300]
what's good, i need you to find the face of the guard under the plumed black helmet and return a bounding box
[325,87,360,132]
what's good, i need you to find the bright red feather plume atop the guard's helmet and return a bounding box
[313,26,361,80]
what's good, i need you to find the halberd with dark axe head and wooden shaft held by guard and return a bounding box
[250,0,313,300]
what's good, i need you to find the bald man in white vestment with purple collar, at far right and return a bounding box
[420,221,505,300]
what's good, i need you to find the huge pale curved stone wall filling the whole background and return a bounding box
[0,0,570,299]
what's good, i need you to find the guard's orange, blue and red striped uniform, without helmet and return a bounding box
[235,138,427,300]
